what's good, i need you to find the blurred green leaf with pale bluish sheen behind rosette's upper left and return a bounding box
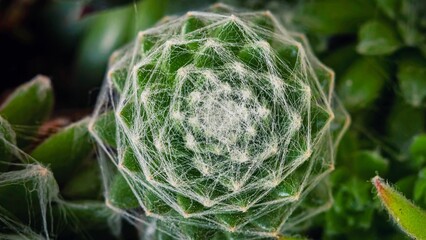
[75,0,168,98]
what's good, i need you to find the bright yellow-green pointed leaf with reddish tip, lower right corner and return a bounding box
[372,176,426,239]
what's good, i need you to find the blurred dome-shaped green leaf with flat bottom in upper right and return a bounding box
[356,20,401,55]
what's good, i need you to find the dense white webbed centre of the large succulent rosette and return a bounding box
[187,76,266,148]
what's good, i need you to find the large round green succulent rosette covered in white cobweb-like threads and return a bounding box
[89,6,348,239]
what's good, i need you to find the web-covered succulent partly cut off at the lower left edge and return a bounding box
[0,117,59,239]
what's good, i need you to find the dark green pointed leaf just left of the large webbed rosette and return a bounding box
[31,118,93,184]
